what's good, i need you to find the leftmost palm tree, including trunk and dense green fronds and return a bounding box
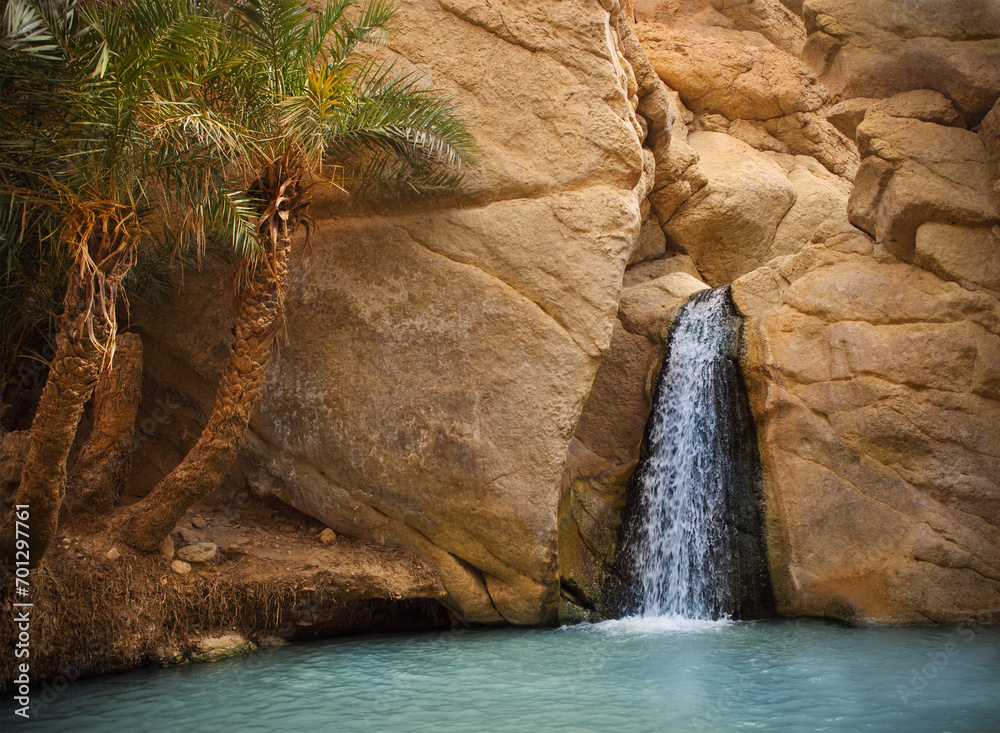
[0,0,258,564]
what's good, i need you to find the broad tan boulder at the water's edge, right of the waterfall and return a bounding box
[733,230,1000,623]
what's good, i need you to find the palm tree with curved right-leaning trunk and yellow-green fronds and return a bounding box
[123,0,472,550]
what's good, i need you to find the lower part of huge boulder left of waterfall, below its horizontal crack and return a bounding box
[245,196,638,623]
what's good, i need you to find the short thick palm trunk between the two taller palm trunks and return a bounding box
[63,333,142,516]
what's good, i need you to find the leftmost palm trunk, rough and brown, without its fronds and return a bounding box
[0,275,107,567]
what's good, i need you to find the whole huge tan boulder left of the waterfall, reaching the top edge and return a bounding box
[135,0,654,624]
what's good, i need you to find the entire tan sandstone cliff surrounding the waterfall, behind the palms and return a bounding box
[136,0,1000,624]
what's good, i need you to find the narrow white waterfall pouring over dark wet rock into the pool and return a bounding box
[618,287,773,619]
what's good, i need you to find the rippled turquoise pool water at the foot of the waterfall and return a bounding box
[2,618,1000,733]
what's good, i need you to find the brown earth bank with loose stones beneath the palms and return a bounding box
[0,494,451,689]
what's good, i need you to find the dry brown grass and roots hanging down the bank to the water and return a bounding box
[0,556,296,689]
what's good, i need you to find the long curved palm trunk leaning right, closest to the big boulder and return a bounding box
[121,222,291,550]
